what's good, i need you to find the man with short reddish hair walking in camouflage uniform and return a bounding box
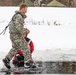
[3,4,30,69]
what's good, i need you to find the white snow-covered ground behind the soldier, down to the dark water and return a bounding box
[0,7,76,64]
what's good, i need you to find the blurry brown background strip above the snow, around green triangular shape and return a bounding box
[0,0,76,7]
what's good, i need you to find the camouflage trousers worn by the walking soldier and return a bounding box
[6,34,30,61]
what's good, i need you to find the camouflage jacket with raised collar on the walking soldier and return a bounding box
[9,11,26,35]
